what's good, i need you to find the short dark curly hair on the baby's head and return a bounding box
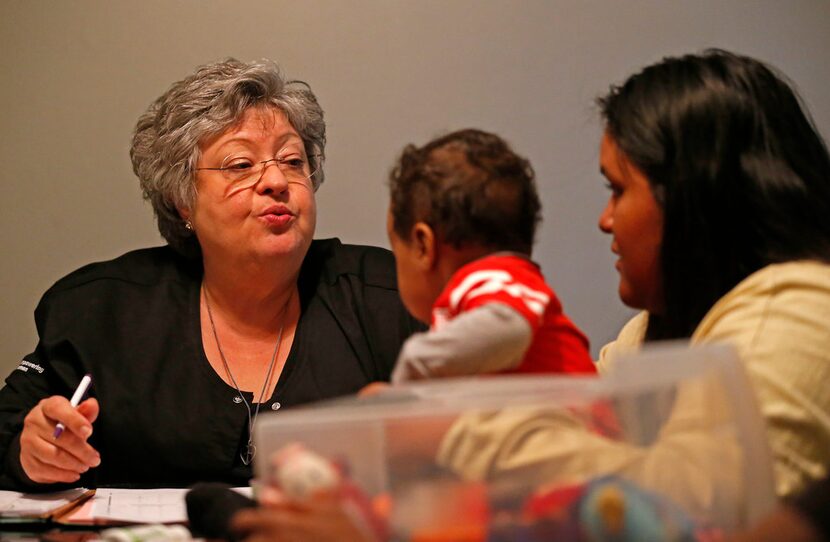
[389,129,541,255]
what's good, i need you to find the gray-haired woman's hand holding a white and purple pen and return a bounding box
[20,375,101,484]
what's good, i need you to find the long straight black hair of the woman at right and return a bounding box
[598,50,830,340]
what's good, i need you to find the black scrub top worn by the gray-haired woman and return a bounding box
[0,239,423,491]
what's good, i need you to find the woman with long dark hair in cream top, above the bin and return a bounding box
[599,50,830,502]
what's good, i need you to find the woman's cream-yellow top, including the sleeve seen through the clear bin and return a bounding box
[438,262,830,525]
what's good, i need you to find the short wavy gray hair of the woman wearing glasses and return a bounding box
[130,58,326,256]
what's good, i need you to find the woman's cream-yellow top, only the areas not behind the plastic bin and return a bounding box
[598,261,830,496]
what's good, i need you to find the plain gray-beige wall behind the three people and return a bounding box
[0,0,830,374]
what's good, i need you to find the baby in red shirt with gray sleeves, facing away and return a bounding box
[387,129,596,383]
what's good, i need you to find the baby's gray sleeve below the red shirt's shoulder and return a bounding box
[392,303,533,383]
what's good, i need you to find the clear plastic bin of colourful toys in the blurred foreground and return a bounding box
[254,346,774,542]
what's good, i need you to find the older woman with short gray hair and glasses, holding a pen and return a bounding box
[0,59,419,489]
